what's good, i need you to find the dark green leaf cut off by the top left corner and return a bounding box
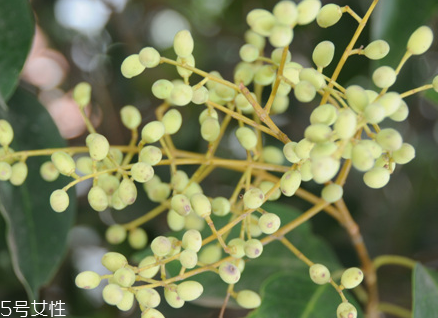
[0,0,34,103]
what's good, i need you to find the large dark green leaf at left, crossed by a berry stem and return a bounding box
[0,90,76,300]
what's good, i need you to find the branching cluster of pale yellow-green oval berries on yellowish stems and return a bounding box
[0,0,438,318]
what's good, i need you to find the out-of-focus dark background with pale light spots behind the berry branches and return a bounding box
[0,0,438,318]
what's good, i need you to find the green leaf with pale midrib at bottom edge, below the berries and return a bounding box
[247,270,363,318]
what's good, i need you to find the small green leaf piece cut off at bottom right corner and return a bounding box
[412,264,438,318]
